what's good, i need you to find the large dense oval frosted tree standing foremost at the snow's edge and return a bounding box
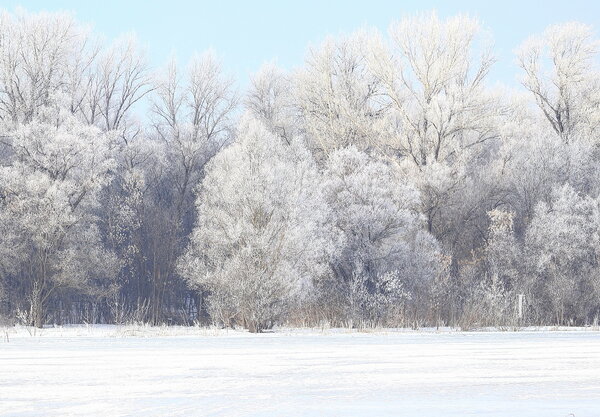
[179,118,334,332]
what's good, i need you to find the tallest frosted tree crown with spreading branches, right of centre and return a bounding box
[370,13,494,167]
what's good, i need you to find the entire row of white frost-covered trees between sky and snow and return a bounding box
[0,12,600,331]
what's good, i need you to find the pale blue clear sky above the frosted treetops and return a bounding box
[0,0,600,87]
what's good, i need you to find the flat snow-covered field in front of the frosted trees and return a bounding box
[0,326,600,417]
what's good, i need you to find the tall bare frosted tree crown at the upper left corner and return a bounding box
[0,11,94,129]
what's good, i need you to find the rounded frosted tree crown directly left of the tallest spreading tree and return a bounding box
[295,32,390,155]
